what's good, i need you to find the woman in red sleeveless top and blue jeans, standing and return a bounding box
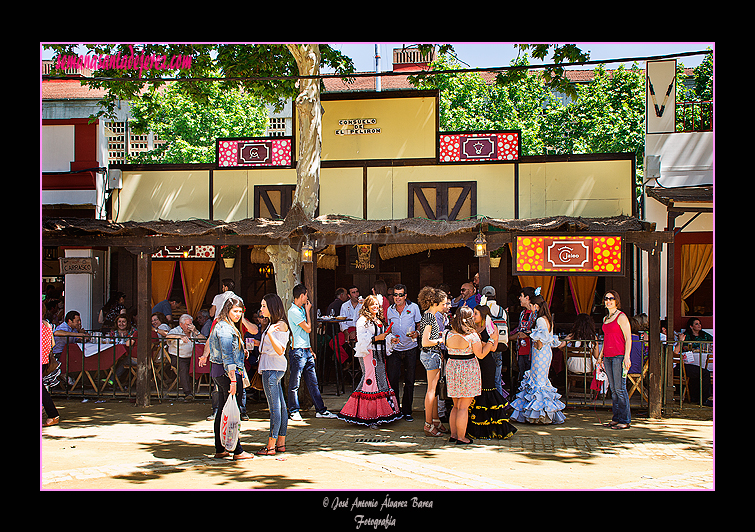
[598,290,632,429]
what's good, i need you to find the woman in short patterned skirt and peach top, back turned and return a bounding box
[445,306,484,445]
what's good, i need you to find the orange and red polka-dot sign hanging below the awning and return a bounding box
[514,235,623,275]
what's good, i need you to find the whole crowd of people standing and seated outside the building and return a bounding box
[42,279,712,454]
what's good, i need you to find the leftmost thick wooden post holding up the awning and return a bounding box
[136,249,152,406]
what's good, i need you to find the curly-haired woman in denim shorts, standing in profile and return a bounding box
[417,286,448,436]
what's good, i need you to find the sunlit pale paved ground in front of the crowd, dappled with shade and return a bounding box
[40,385,714,494]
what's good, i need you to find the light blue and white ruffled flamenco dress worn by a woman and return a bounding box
[511,317,566,424]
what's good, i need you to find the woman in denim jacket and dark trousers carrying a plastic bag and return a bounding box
[199,297,254,460]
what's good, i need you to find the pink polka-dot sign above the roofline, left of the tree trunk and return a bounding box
[217,137,293,168]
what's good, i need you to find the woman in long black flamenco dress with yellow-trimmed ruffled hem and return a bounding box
[467,305,516,440]
